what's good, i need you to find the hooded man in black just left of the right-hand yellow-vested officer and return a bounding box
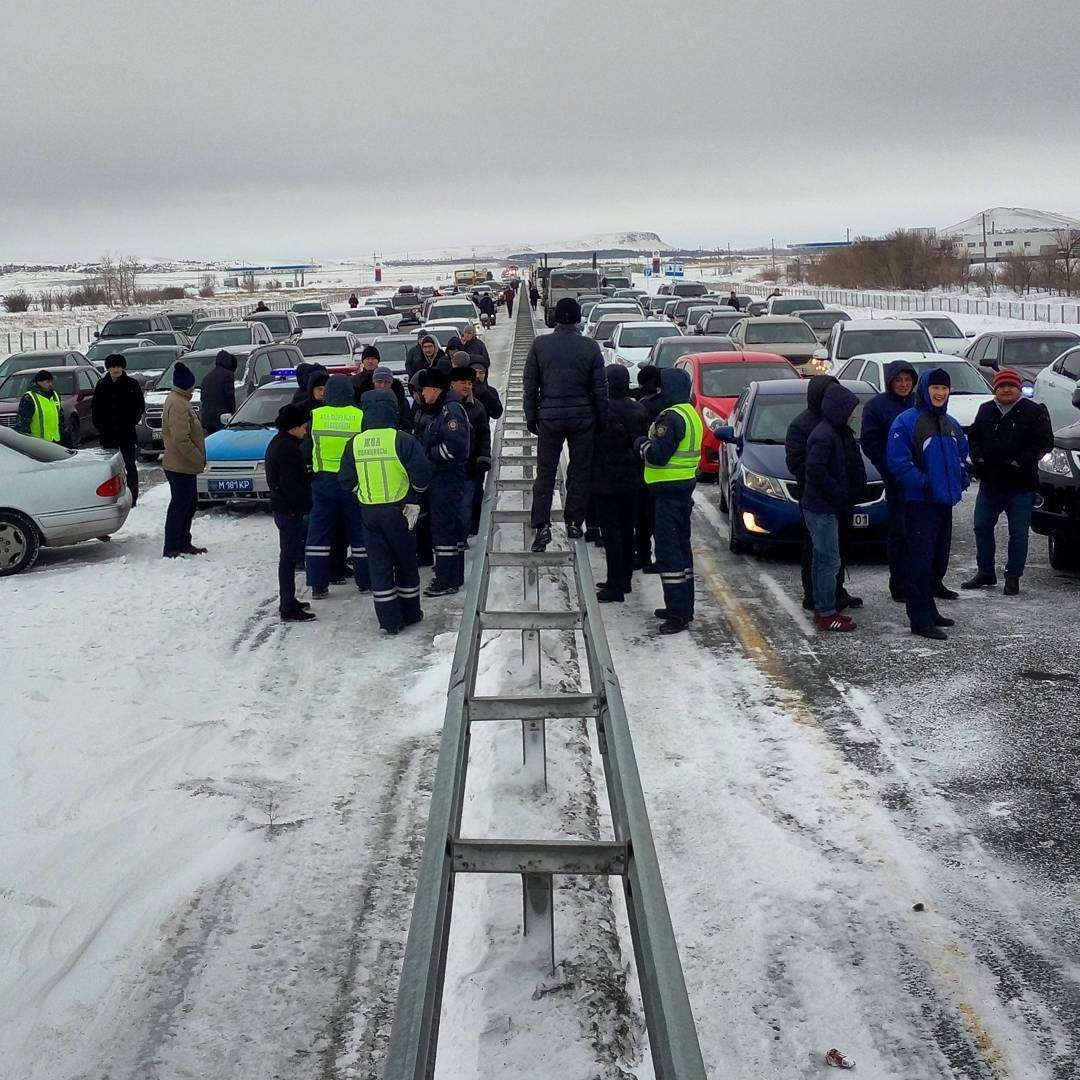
[590,364,649,604]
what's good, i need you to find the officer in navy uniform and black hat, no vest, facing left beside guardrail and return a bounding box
[417,368,470,596]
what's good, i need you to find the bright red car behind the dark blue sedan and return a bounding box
[675,352,801,481]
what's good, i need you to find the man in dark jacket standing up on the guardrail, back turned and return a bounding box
[524,296,608,552]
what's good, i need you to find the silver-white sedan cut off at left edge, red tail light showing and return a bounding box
[0,428,132,576]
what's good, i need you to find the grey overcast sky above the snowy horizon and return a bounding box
[0,0,1080,262]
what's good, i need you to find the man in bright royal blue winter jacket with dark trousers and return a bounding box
[886,367,971,642]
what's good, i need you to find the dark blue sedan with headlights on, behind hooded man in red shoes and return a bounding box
[715,379,888,552]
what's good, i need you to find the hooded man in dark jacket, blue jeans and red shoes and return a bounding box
[800,381,866,631]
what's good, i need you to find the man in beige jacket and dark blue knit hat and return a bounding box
[161,361,206,558]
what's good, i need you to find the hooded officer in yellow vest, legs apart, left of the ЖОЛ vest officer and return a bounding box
[305,375,370,600]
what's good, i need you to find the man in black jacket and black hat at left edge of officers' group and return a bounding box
[266,404,314,622]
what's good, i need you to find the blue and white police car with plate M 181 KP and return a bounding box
[195,378,296,507]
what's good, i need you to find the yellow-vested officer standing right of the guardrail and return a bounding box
[634,367,704,634]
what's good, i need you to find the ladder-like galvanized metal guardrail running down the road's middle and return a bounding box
[384,302,705,1080]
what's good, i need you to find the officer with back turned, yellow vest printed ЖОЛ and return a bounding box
[338,389,431,634]
